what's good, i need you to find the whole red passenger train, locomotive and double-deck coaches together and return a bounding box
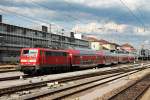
[20,48,135,74]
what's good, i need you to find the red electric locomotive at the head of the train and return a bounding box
[20,48,71,74]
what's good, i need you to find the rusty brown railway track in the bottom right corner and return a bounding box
[110,74,150,100]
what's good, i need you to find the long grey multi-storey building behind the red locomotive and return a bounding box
[0,22,89,62]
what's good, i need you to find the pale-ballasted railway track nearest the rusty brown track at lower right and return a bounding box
[29,71,139,99]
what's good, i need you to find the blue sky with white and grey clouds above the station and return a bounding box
[0,0,150,48]
